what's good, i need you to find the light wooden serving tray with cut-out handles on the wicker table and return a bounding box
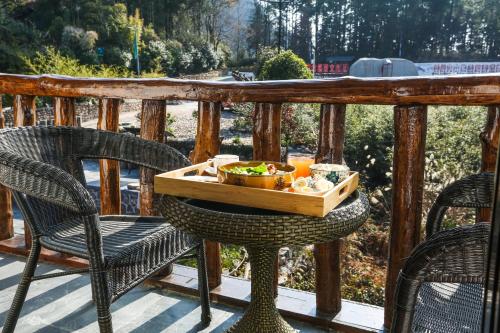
[154,162,359,217]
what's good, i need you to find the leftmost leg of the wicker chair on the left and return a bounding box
[2,237,41,333]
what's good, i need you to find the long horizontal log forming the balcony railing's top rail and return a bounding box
[0,73,500,105]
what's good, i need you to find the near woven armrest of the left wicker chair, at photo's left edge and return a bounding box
[0,151,97,215]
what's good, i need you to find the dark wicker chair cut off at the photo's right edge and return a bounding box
[391,173,494,333]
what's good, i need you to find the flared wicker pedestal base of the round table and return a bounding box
[227,247,296,333]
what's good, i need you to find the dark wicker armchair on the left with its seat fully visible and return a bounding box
[0,127,211,332]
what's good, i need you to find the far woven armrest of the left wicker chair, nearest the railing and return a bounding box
[73,128,190,172]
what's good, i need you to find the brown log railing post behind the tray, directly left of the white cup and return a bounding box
[190,102,222,289]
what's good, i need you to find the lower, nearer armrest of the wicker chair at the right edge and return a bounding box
[387,223,490,332]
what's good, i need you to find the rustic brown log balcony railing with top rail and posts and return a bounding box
[0,74,500,331]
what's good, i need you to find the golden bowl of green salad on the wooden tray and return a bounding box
[217,161,295,190]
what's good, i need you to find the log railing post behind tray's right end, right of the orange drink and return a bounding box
[314,104,346,315]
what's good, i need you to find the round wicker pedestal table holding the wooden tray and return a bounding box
[161,191,369,333]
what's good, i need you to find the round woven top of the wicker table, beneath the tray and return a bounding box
[161,191,369,247]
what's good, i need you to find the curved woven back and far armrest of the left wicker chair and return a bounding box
[0,127,189,235]
